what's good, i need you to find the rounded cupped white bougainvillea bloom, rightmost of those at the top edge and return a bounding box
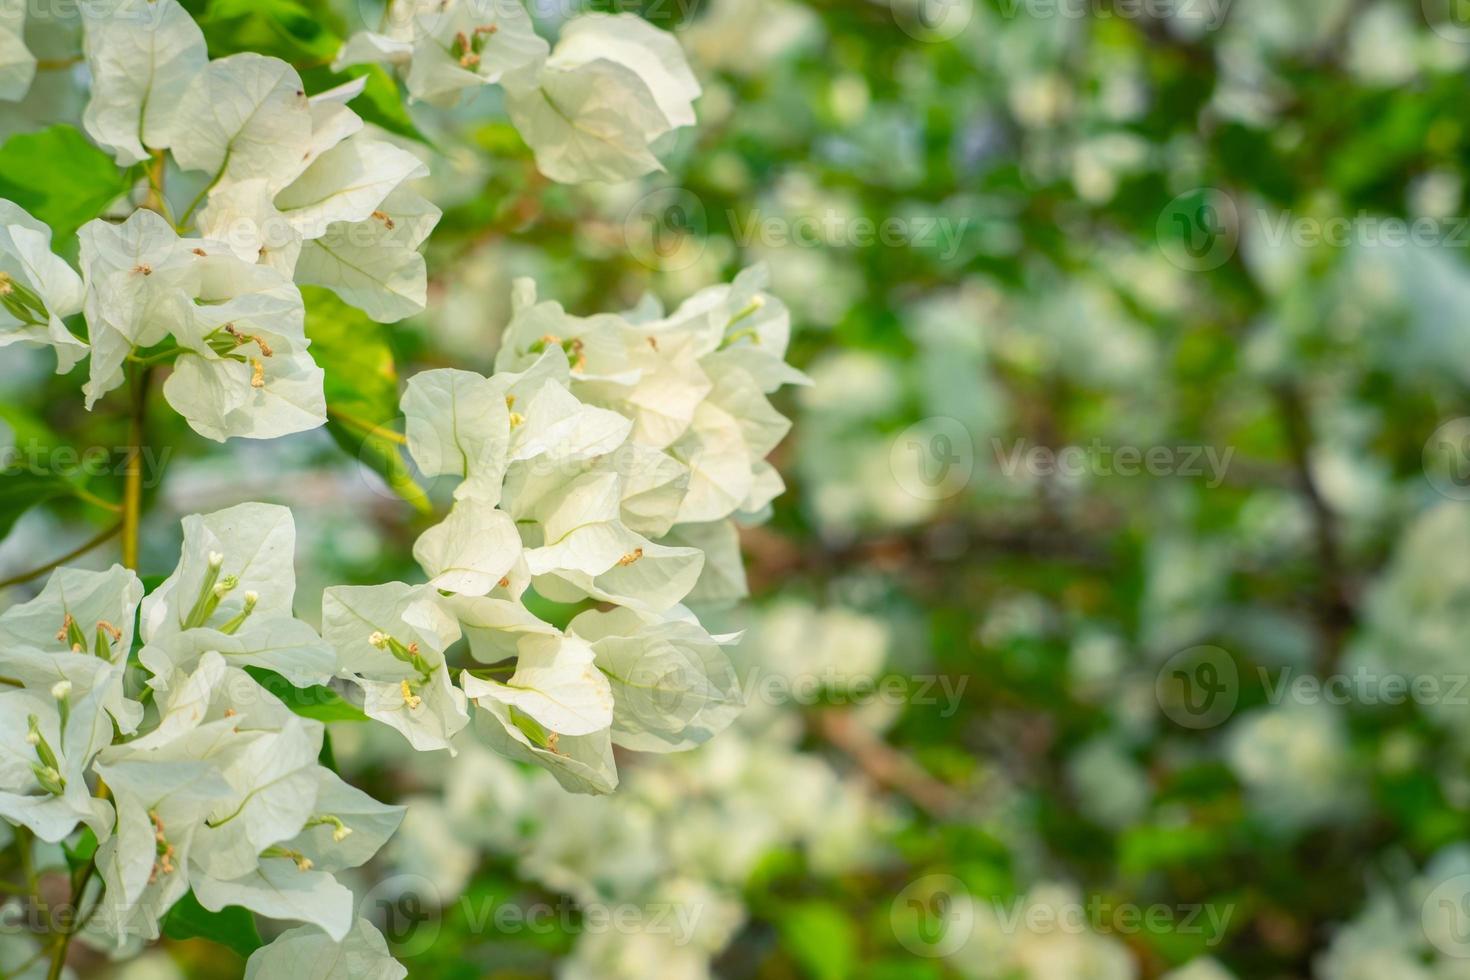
[504,13,700,184]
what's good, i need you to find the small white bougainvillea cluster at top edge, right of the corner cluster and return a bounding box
[335,0,700,184]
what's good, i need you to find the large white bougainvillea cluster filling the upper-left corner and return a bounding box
[0,0,440,441]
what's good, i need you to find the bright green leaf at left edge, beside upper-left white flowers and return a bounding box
[0,126,131,242]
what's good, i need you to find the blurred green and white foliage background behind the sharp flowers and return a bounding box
[0,0,1470,980]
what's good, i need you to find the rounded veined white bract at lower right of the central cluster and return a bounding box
[567,608,745,752]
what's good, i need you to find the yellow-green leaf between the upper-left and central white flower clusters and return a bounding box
[301,287,434,514]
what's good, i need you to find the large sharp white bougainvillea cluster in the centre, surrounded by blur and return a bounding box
[322,269,801,793]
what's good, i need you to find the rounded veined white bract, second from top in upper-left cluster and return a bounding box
[172,51,312,184]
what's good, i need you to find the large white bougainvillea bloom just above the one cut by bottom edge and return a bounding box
[97,652,385,937]
